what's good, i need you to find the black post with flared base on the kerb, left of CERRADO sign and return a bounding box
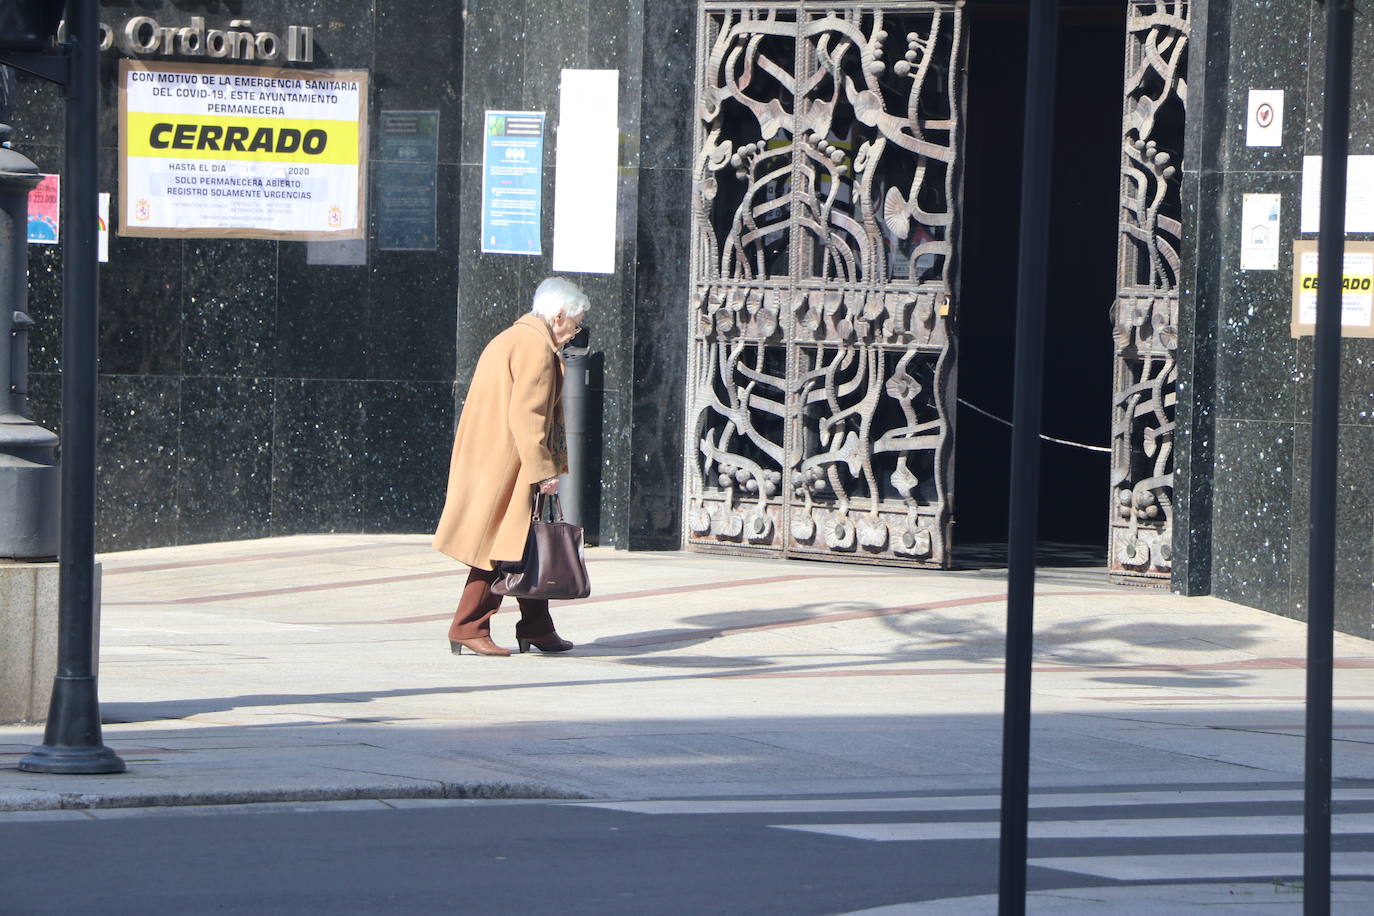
[0,0,124,773]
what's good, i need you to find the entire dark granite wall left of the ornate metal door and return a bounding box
[14,0,695,549]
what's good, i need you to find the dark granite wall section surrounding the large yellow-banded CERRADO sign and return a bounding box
[14,0,463,551]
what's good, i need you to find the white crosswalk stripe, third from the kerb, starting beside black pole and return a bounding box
[1028,853,1374,882]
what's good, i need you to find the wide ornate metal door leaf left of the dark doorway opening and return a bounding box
[684,0,963,566]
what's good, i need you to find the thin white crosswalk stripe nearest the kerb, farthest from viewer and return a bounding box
[577,788,1374,814]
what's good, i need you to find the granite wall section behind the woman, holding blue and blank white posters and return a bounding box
[456,0,695,548]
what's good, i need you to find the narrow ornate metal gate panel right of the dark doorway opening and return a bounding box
[1109,0,1189,585]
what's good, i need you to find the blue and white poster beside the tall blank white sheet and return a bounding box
[482,111,544,254]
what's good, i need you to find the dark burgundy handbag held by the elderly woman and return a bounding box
[492,493,592,602]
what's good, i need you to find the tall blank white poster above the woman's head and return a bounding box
[554,70,620,273]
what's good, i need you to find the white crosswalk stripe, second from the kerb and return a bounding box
[769,813,1374,843]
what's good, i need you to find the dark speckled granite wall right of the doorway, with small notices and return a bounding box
[1175,0,1374,637]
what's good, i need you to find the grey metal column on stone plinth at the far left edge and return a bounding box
[0,114,60,560]
